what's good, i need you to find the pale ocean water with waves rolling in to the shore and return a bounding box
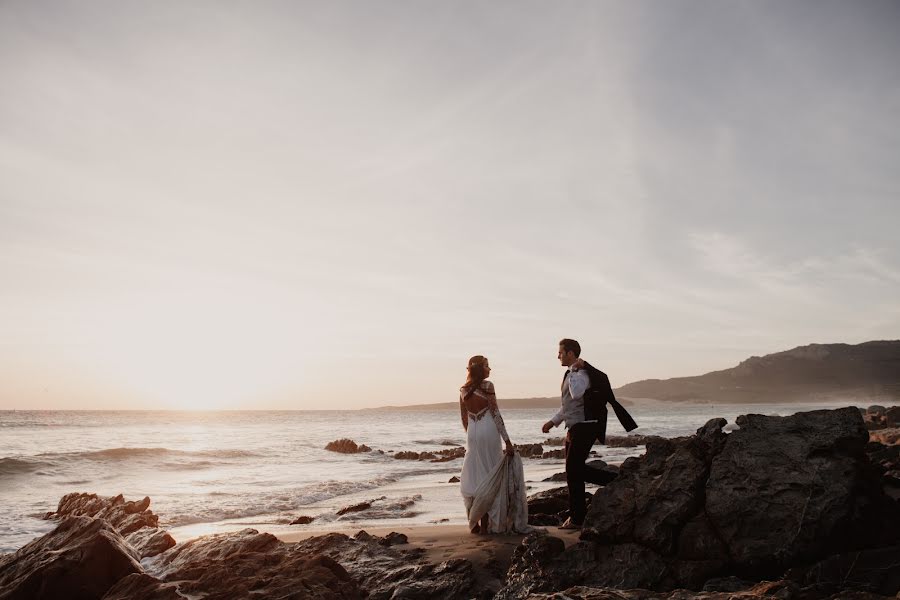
[0,401,850,553]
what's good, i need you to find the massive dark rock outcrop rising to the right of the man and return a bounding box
[501,408,900,598]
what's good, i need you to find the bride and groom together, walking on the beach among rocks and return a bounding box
[459,338,637,533]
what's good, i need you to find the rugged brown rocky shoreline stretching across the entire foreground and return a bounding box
[0,407,900,600]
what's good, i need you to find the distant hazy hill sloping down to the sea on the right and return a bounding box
[616,340,900,403]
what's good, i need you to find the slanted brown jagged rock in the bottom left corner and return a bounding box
[0,515,142,600]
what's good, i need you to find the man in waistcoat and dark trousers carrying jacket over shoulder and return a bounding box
[541,338,624,529]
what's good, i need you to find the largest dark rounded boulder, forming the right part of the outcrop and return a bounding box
[705,408,900,576]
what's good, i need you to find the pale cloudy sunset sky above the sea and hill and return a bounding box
[0,0,900,410]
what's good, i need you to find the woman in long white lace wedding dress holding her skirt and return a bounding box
[459,356,532,533]
